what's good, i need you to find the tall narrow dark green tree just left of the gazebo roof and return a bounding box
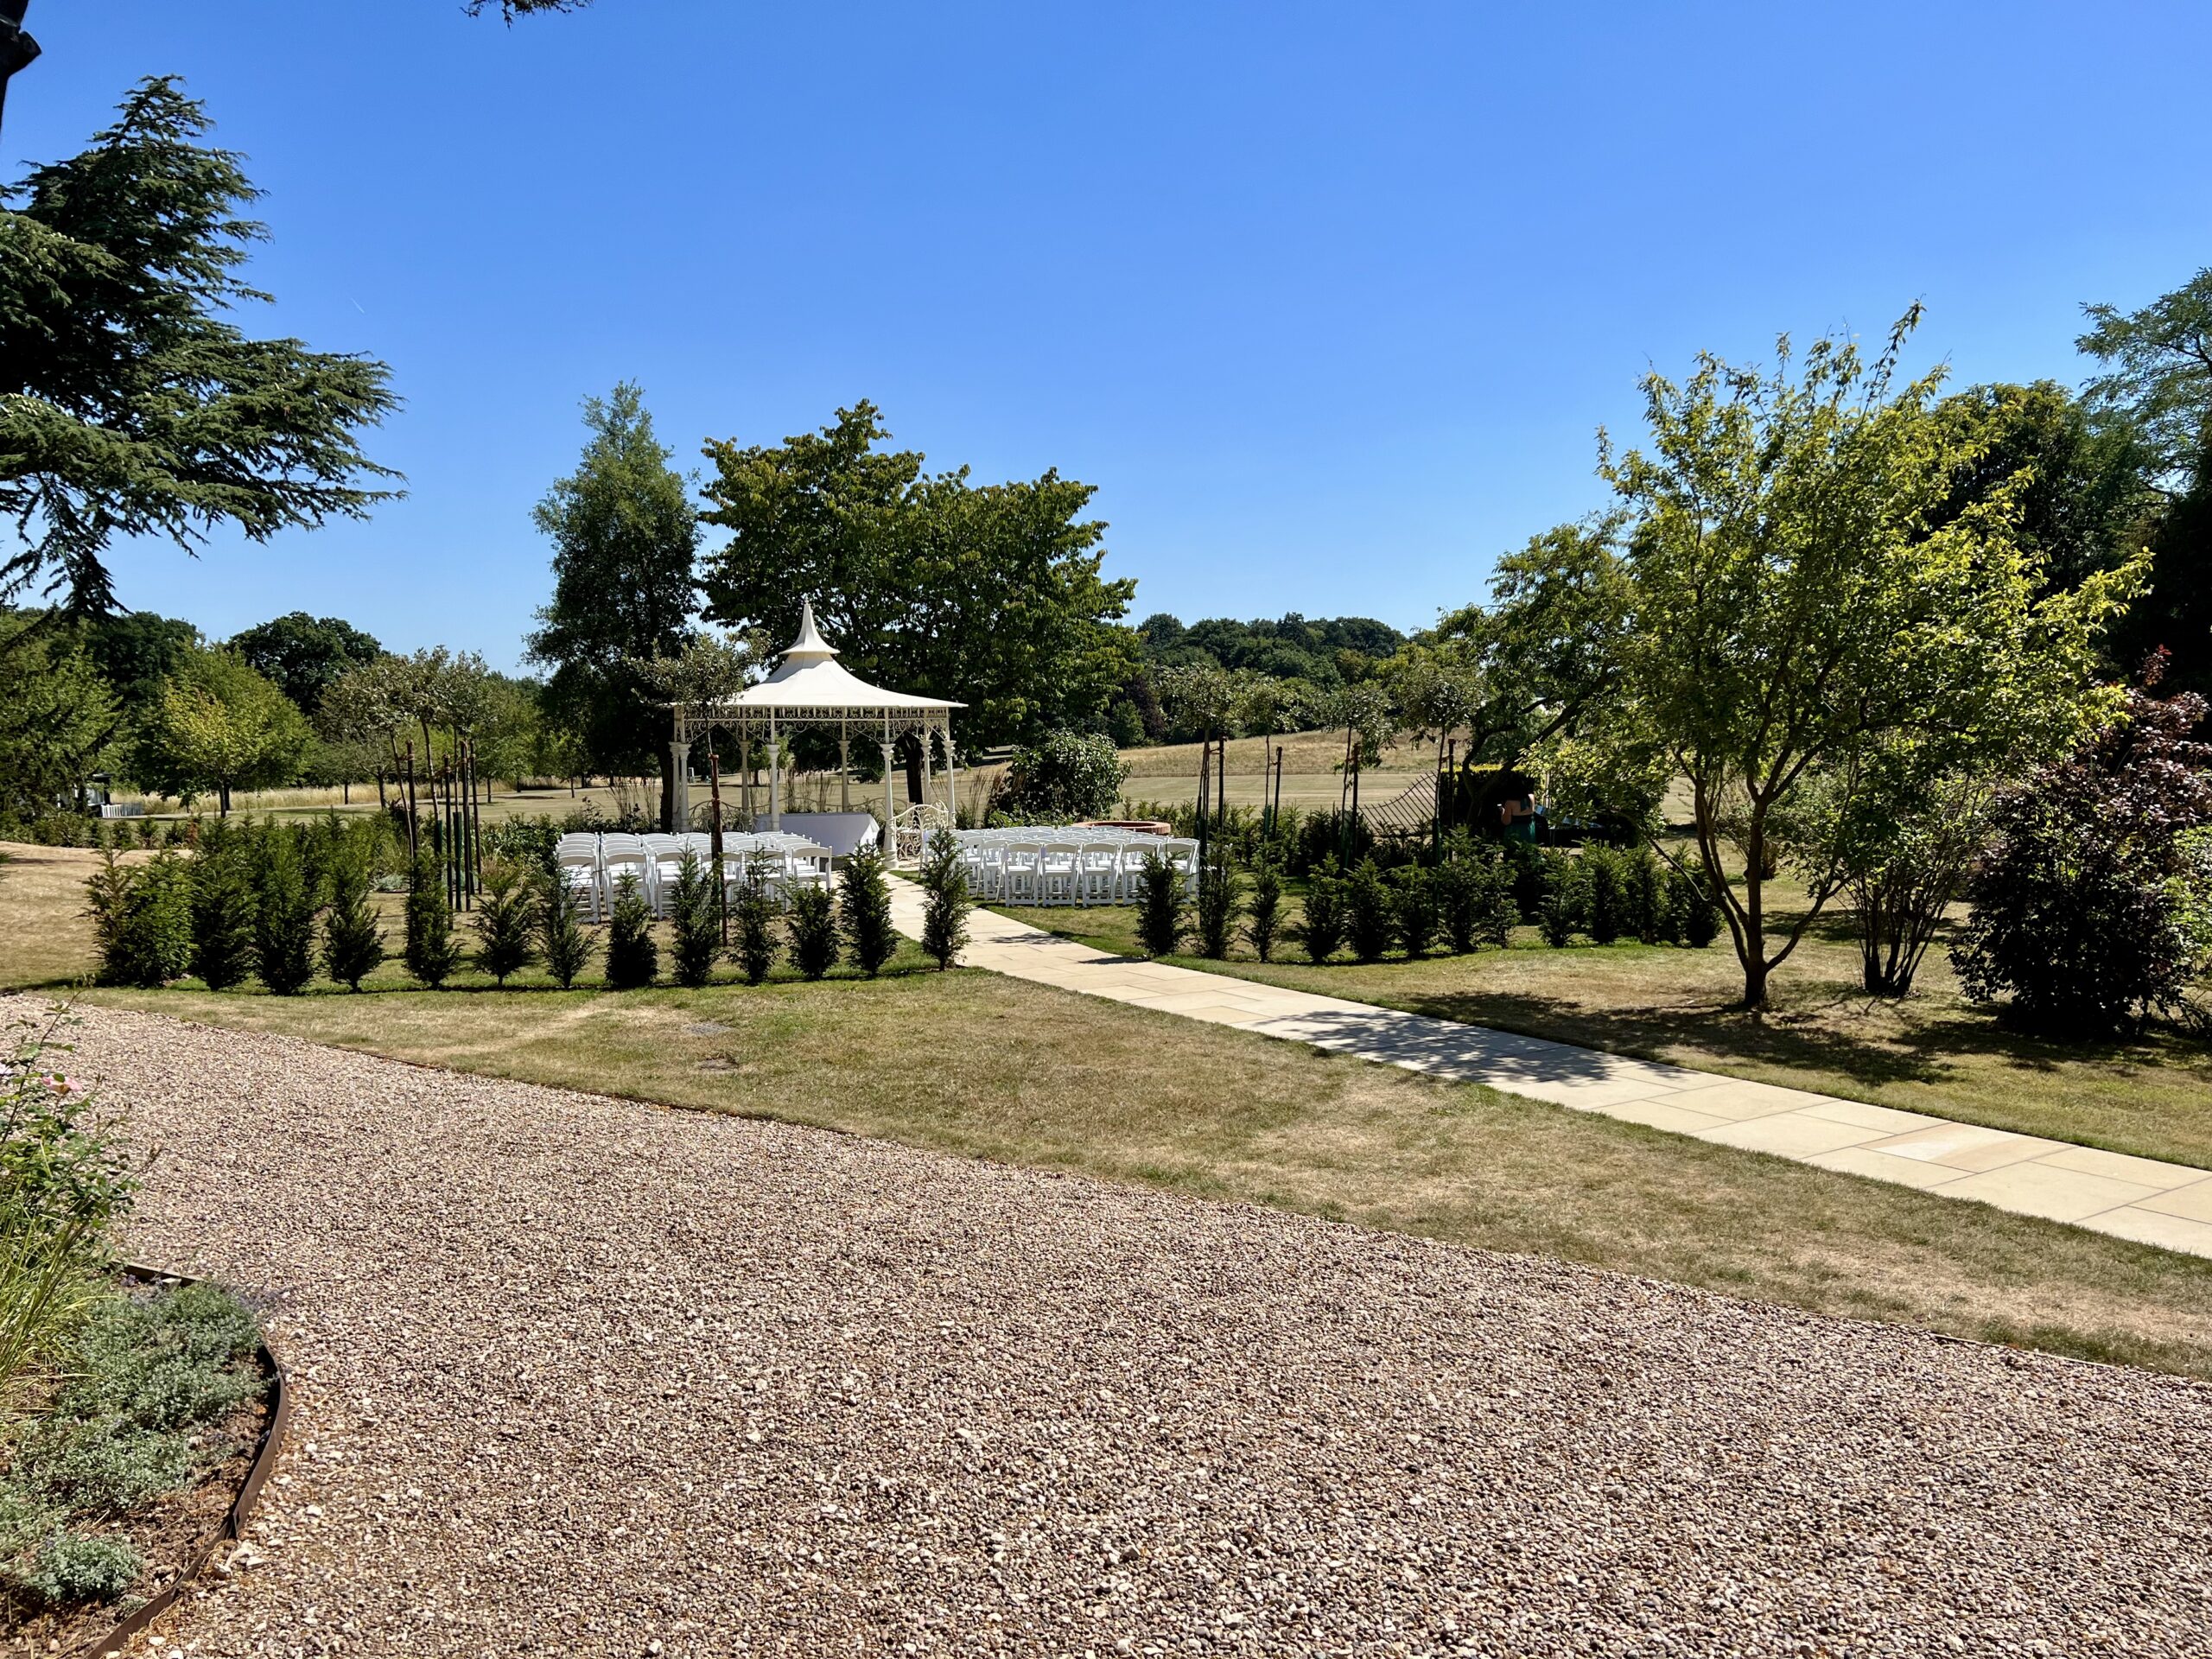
[529,380,699,823]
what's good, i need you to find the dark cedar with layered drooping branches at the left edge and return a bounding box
[0,78,394,615]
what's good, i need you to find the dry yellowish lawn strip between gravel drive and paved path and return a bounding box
[13,849,2212,1376]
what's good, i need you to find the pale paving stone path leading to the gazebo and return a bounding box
[892,878,2212,1256]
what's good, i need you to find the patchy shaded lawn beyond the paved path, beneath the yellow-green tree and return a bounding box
[1008,887,2212,1166]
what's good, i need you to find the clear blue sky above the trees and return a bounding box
[0,0,2212,664]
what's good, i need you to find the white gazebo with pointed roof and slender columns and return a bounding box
[668,600,967,849]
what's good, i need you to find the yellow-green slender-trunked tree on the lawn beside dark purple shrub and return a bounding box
[1581,308,2137,1008]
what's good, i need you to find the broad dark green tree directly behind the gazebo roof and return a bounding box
[702,403,1139,774]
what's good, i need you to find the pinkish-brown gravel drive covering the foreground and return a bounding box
[52,1011,2212,1656]
